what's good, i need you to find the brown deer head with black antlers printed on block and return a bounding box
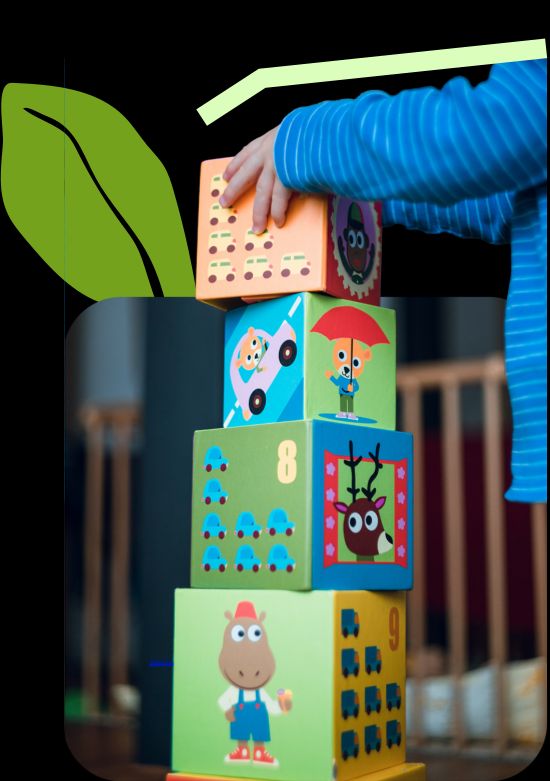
[334,439,393,561]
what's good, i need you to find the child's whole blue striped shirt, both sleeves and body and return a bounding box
[274,60,547,502]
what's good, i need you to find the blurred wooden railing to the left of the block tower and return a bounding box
[80,405,140,716]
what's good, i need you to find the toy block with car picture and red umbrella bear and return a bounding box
[223,293,396,429]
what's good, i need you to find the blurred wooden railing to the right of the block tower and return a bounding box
[397,355,547,754]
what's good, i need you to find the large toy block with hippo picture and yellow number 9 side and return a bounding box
[172,589,406,781]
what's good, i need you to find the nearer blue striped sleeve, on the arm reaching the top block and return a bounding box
[274,60,546,206]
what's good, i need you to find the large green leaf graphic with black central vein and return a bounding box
[1,84,195,300]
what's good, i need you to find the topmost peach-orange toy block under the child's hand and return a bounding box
[196,158,382,309]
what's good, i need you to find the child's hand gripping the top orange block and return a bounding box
[220,127,292,233]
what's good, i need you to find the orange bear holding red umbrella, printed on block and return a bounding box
[311,306,390,420]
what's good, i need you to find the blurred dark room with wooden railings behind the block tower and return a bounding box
[65,297,546,781]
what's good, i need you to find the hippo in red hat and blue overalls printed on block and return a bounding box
[218,602,292,767]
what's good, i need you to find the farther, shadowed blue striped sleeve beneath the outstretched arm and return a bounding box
[382,193,514,244]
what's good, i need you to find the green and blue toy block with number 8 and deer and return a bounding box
[191,420,413,588]
